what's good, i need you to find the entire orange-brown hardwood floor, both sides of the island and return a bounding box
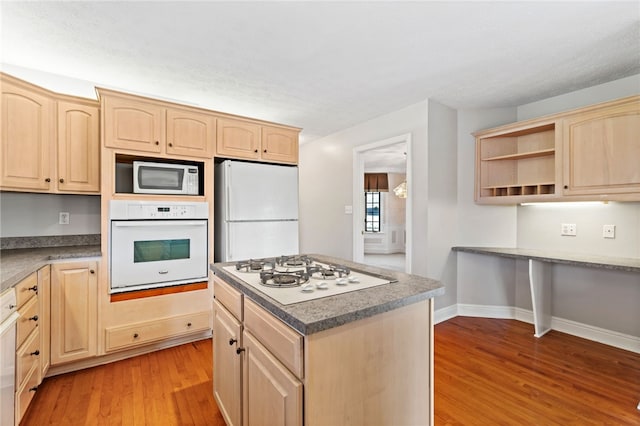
[22,317,640,426]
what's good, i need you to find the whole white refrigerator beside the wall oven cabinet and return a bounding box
[214,160,298,262]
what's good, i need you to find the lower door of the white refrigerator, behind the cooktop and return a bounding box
[223,220,298,262]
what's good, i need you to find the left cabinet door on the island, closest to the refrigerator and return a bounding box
[213,301,242,426]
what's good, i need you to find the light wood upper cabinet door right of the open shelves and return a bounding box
[563,100,640,195]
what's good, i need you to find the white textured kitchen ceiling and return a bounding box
[0,1,640,142]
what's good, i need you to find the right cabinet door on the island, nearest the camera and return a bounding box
[242,330,302,426]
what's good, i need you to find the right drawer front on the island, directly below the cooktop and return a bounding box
[244,299,304,378]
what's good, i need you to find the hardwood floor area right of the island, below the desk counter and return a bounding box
[434,317,640,425]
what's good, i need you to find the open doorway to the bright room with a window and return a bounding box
[353,134,412,273]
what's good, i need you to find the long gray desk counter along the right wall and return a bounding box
[452,247,640,272]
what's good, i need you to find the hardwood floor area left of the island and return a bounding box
[20,339,225,426]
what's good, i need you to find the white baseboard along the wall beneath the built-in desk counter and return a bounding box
[434,303,640,353]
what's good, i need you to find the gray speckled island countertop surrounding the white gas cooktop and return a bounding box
[211,254,444,335]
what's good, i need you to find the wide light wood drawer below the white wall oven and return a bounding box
[106,311,211,351]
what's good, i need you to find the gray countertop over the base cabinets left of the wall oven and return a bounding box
[0,245,101,291]
